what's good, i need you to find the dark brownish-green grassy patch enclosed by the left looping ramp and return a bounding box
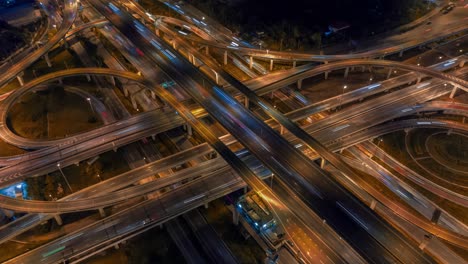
[8,85,102,139]
